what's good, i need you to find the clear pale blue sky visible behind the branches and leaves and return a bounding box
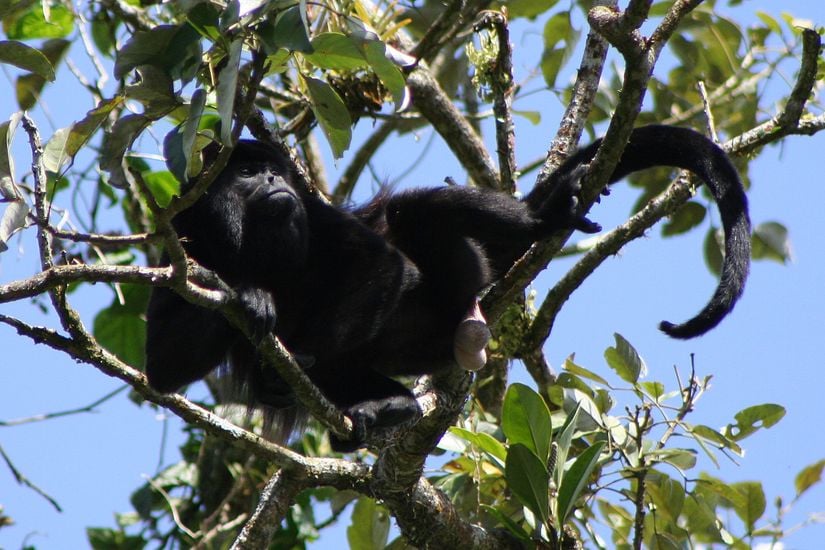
[0,0,825,550]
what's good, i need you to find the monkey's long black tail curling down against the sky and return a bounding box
[527,125,751,338]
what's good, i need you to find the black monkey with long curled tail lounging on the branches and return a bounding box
[146,126,750,451]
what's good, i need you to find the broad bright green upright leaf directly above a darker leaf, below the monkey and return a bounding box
[501,384,553,462]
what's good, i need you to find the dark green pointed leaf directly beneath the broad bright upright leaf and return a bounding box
[504,443,550,524]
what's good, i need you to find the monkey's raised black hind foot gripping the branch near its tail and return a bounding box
[538,165,602,233]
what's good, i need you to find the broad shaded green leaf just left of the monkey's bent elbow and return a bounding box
[94,284,150,368]
